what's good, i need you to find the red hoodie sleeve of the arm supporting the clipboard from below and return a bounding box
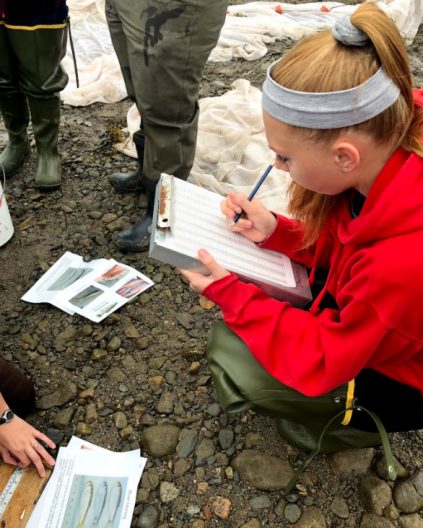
[203,274,392,396]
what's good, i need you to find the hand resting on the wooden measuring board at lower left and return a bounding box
[0,415,56,477]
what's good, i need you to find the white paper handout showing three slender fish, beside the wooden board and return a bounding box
[27,437,147,528]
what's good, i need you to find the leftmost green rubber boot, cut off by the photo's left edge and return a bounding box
[0,93,31,176]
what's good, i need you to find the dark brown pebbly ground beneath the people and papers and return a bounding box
[0,2,423,528]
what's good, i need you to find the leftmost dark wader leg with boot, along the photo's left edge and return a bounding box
[0,26,31,176]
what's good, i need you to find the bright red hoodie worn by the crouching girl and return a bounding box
[203,90,423,396]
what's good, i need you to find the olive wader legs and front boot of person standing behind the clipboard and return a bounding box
[107,0,228,251]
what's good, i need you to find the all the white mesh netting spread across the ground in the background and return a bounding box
[62,0,423,212]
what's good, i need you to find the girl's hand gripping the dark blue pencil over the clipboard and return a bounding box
[220,192,277,243]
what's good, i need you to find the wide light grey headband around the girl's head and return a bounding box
[262,63,400,129]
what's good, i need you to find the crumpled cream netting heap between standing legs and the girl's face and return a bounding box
[116,79,290,214]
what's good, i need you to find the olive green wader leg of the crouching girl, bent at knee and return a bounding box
[207,321,381,452]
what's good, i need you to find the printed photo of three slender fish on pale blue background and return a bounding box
[61,475,128,528]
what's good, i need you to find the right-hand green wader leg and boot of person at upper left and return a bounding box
[8,23,68,190]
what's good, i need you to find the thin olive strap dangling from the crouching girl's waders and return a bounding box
[283,404,397,495]
